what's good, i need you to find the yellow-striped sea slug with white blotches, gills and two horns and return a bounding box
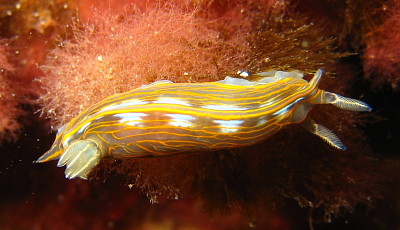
[36,70,371,179]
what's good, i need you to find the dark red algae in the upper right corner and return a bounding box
[292,0,400,90]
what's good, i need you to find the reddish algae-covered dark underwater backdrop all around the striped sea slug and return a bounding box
[0,0,400,230]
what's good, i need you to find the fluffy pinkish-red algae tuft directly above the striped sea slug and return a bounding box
[40,8,249,126]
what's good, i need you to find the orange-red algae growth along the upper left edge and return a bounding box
[0,0,80,141]
